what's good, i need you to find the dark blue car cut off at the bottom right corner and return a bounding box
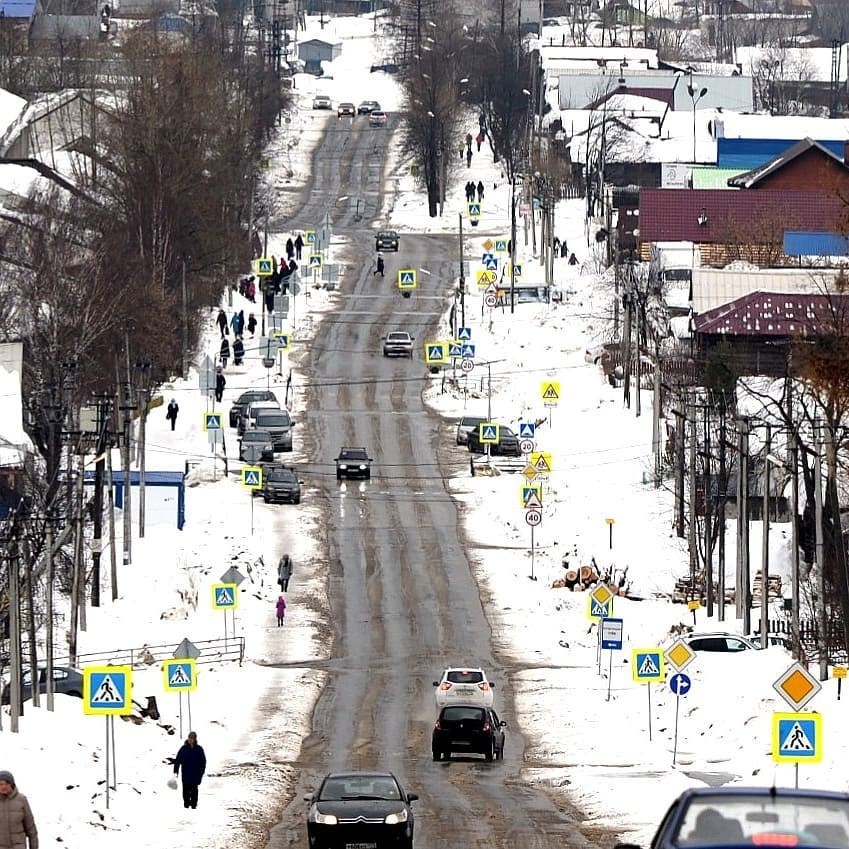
[614,784,849,849]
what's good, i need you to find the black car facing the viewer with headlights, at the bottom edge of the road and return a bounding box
[304,772,419,849]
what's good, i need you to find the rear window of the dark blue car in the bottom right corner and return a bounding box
[673,792,849,849]
